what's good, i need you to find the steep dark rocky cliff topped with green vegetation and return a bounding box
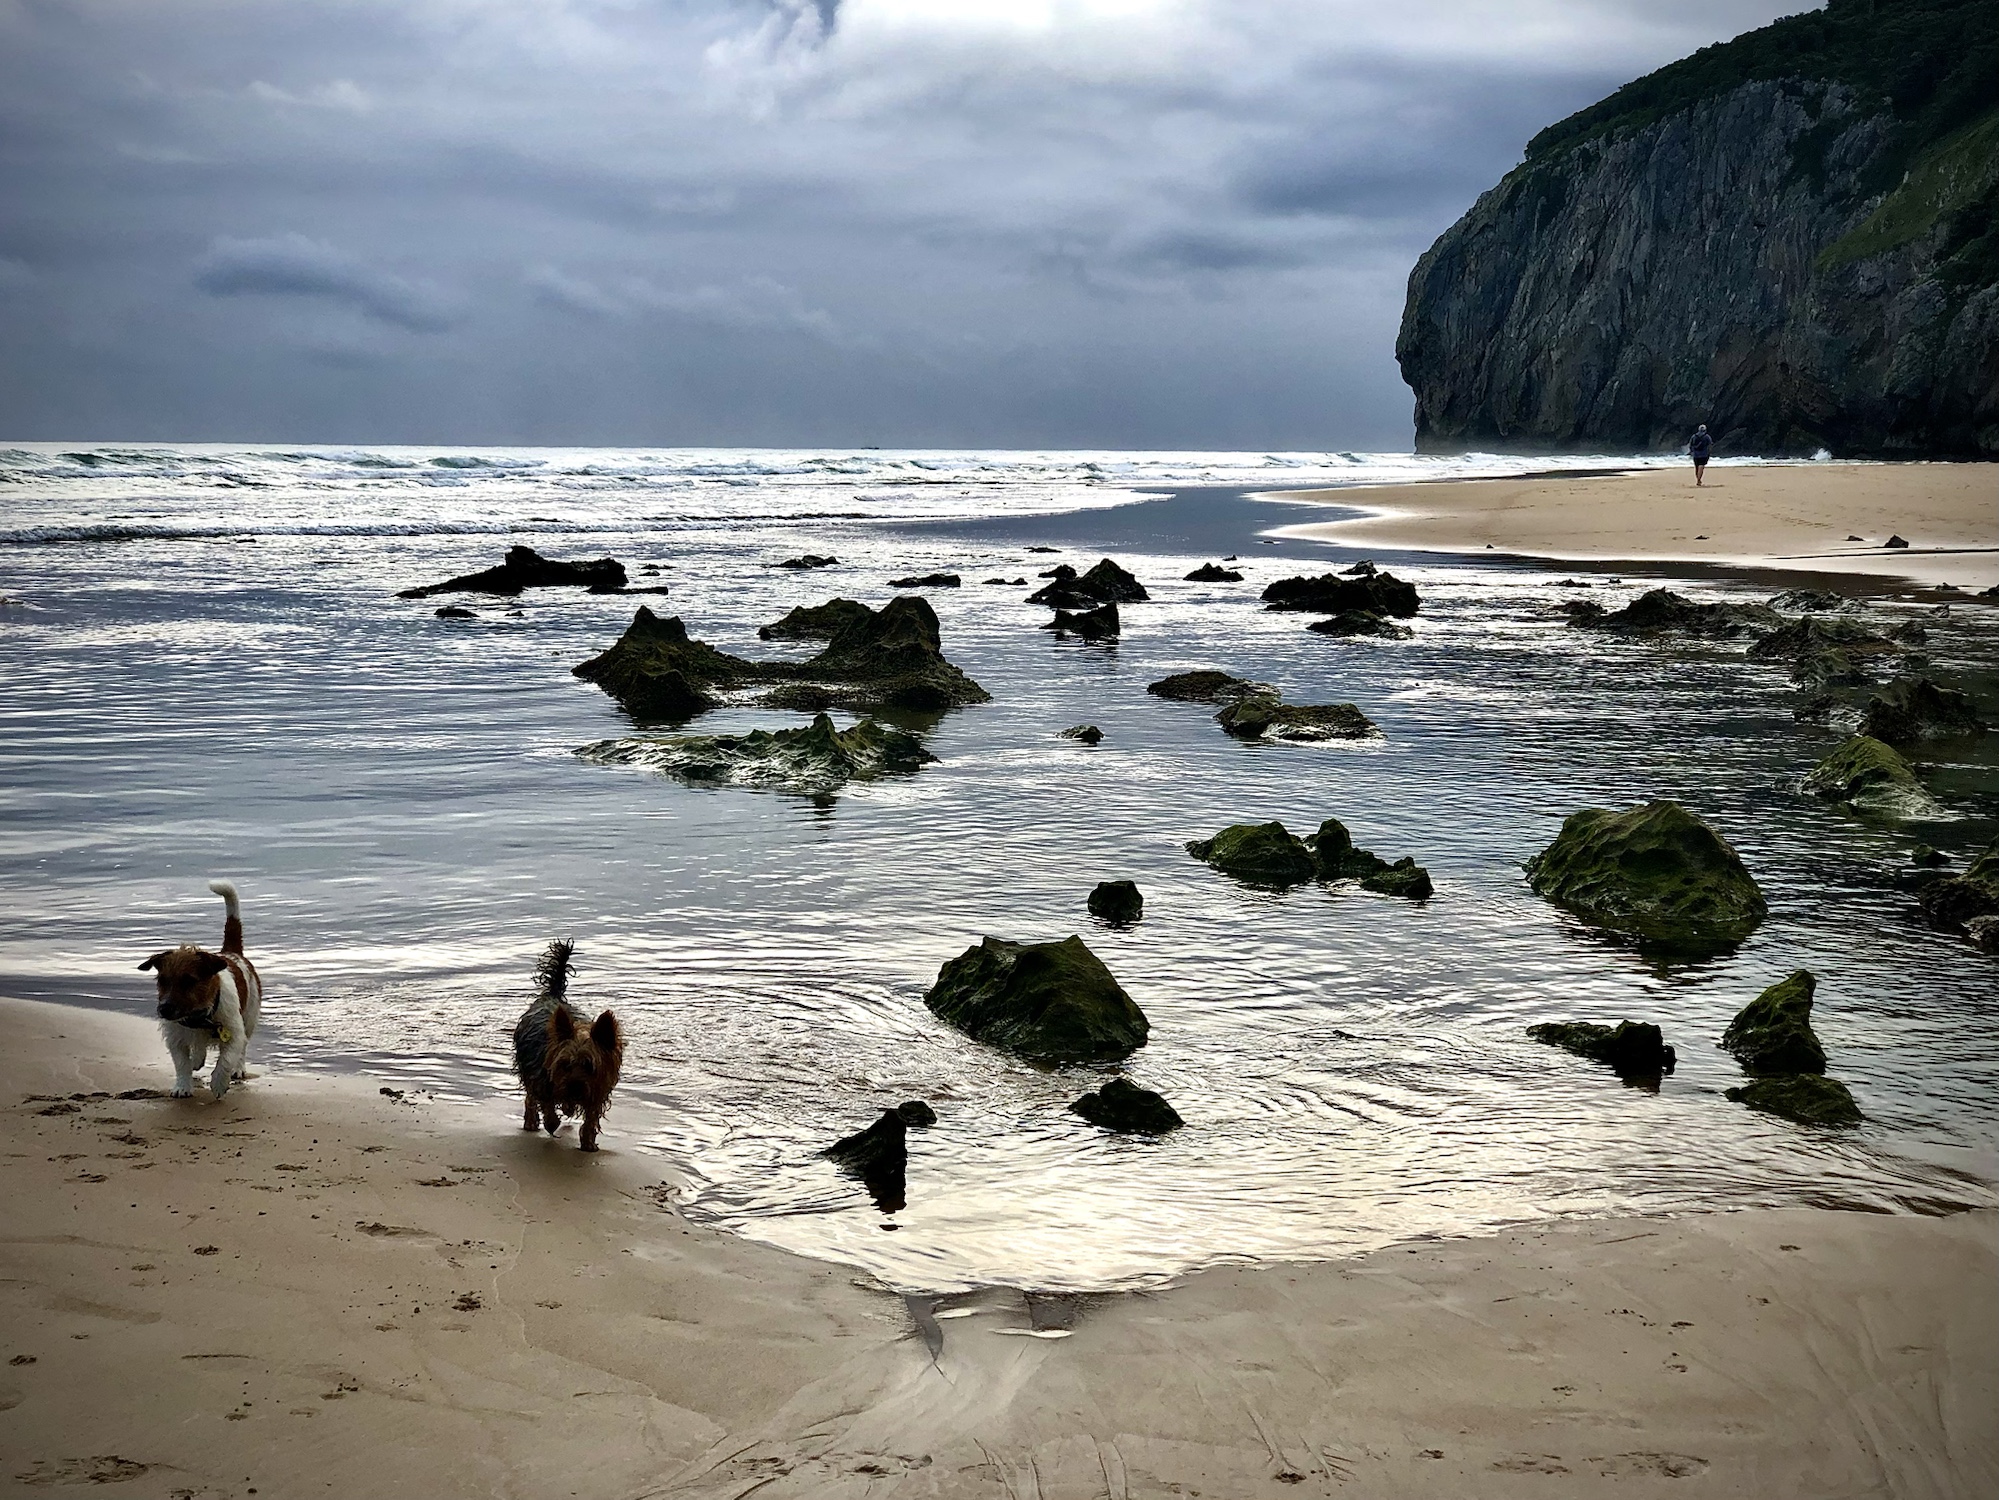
[1395,0,1999,458]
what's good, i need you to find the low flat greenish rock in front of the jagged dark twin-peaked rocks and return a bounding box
[576,714,936,792]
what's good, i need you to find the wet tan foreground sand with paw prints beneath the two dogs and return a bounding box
[0,1000,1999,1500]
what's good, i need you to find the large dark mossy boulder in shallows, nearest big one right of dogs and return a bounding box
[924,936,1149,1064]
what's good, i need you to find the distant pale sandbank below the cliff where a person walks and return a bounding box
[1283,464,1999,590]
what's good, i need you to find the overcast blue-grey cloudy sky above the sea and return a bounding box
[0,0,1803,448]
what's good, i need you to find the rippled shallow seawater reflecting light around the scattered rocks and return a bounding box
[0,448,1999,1290]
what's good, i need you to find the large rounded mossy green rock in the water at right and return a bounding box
[1525,802,1767,952]
